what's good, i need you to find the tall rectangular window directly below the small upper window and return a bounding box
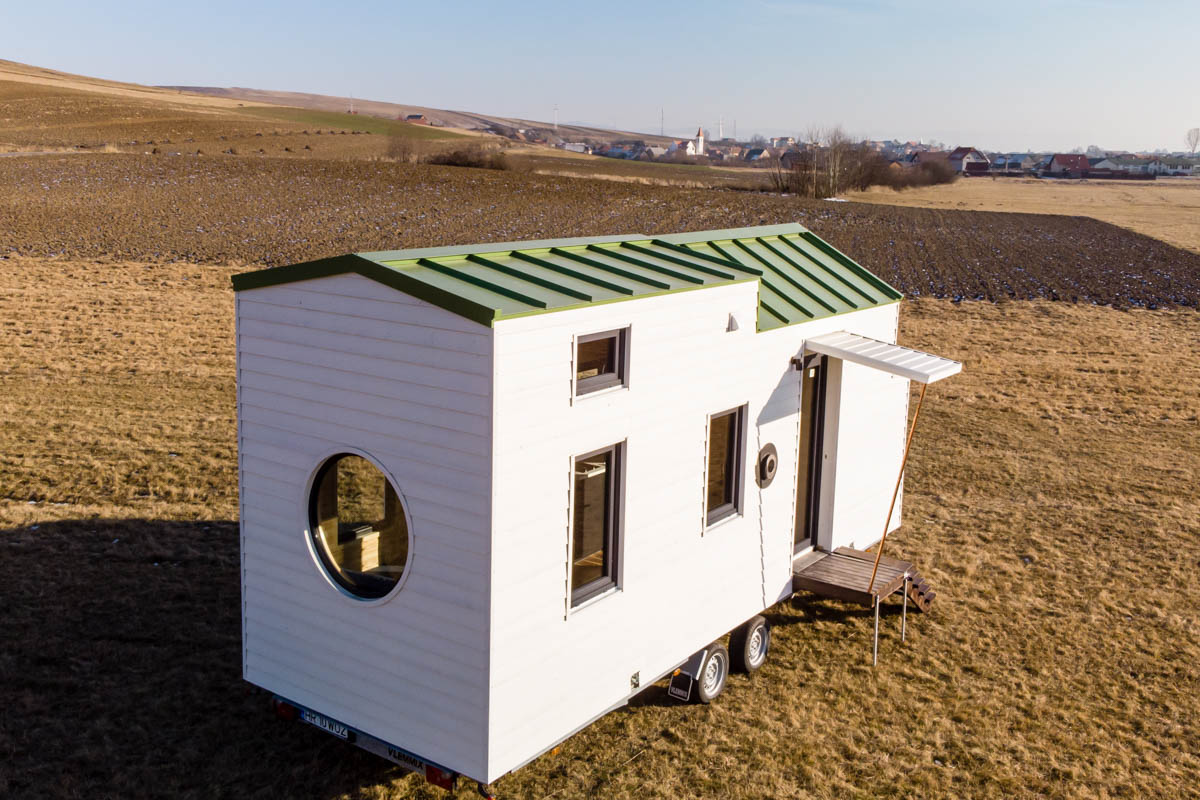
[571,445,622,606]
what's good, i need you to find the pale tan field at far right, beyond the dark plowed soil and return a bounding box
[846,178,1200,253]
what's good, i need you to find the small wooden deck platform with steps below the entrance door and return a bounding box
[792,547,912,607]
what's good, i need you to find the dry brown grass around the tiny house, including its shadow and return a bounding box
[0,259,1200,799]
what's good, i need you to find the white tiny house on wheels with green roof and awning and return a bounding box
[234,224,954,786]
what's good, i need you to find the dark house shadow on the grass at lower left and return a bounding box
[0,519,432,798]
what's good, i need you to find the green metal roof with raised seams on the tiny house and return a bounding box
[233,224,901,331]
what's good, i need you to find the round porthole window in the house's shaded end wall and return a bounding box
[308,453,408,600]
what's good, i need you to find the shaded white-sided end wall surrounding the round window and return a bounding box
[238,275,492,775]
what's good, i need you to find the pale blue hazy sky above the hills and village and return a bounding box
[0,0,1200,151]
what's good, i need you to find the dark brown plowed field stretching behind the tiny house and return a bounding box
[7,154,1200,308]
